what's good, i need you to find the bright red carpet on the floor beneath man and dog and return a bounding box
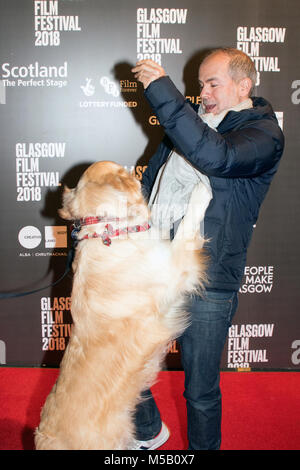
[0,367,300,450]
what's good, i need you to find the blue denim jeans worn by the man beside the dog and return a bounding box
[135,291,238,450]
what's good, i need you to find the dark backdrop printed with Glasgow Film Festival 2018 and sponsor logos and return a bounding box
[0,0,300,370]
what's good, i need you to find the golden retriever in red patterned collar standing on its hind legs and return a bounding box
[35,161,211,450]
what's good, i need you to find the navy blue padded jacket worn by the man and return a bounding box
[142,77,284,290]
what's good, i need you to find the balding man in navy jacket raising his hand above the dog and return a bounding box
[133,48,284,450]
